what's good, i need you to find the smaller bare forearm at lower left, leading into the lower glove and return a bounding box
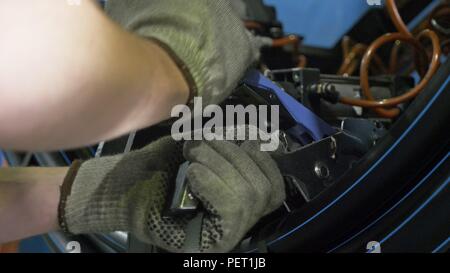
[0,168,67,244]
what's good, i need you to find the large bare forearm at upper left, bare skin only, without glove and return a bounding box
[0,0,188,150]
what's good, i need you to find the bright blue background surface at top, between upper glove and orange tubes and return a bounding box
[264,0,371,48]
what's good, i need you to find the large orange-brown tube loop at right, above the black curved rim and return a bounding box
[340,30,441,118]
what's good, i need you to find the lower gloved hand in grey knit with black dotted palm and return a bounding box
[59,137,285,252]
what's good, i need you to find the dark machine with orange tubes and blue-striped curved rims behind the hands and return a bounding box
[4,0,450,252]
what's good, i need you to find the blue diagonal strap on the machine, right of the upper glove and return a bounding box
[243,70,337,144]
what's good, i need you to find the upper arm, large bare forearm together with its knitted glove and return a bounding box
[0,0,258,150]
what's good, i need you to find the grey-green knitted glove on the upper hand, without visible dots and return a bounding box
[106,0,262,104]
